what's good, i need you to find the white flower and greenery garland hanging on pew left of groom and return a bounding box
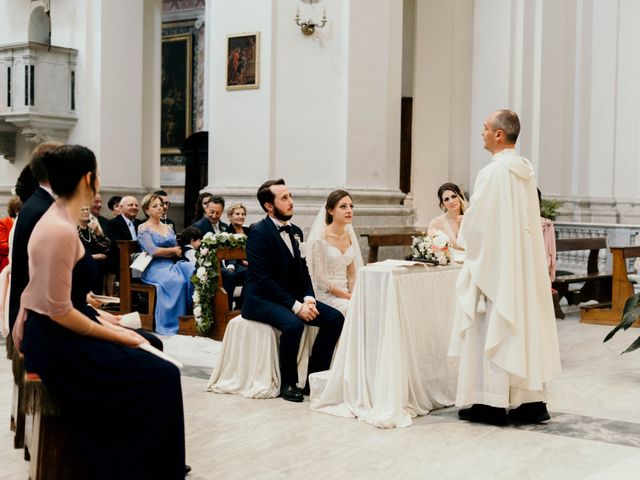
[191,232,247,334]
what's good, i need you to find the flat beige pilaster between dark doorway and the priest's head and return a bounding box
[411,0,482,227]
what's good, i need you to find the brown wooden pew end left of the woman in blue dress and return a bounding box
[118,240,156,331]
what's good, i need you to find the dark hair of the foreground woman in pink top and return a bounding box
[42,145,97,198]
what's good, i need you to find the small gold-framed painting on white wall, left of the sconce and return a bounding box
[226,32,260,90]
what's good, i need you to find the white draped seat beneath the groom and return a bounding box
[207,315,318,398]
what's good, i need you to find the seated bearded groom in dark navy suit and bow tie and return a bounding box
[242,179,344,402]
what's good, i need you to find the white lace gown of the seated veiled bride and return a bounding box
[308,238,355,315]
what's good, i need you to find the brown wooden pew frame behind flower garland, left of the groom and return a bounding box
[179,248,247,341]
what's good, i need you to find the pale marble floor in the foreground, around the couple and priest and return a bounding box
[0,313,640,480]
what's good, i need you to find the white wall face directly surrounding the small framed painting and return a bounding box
[205,0,273,189]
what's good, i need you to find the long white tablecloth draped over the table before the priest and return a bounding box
[310,262,459,428]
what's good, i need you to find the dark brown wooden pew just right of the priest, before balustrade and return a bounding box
[552,238,612,316]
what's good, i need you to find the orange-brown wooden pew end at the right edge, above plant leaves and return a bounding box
[580,246,640,327]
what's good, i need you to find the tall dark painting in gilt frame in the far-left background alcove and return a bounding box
[160,34,192,154]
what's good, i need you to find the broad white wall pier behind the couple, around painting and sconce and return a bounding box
[207,0,411,232]
